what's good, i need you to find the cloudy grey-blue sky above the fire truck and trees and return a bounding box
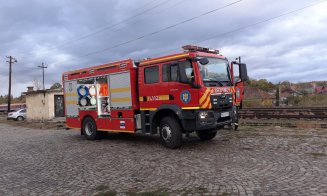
[0,0,327,96]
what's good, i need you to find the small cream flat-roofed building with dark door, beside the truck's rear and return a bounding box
[26,89,64,121]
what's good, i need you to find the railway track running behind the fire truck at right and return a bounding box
[240,107,327,119]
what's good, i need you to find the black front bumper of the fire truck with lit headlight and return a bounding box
[182,108,233,131]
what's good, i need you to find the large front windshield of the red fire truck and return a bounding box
[199,58,232,86]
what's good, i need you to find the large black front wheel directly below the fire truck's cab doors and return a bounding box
[160,116,183,149]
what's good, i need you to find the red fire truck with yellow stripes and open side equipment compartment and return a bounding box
[62,45,247,148]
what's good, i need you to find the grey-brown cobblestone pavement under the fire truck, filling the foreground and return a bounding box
[0,124,327,195]
